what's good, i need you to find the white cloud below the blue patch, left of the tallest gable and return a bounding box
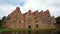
[0,5,15,18]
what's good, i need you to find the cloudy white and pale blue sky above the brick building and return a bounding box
[0,0,60,18]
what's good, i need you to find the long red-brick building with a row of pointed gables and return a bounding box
[3,7,56,29]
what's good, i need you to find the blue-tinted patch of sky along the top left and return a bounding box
[0,0,25,6]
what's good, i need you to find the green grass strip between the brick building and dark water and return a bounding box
[0,28,56,32]
